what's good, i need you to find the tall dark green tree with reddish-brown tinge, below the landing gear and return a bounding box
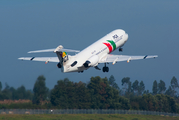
[87,76,120,109]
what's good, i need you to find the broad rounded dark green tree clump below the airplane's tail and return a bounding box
[50,78,91,109]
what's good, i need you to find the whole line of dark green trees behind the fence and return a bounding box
[0,75,179,113]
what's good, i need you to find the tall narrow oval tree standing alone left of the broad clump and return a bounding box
[33,75,48,104]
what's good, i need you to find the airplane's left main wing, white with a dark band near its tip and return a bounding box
[18,57,59,63]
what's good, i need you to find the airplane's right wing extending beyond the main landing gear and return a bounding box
[99,54,158,64]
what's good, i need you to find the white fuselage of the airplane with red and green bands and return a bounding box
[61,29,128,72]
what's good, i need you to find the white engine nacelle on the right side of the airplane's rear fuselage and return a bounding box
[83,55,99,68]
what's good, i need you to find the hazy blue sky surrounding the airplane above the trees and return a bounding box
[0,0,179,91]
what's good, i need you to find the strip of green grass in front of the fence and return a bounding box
[0,114,179,120]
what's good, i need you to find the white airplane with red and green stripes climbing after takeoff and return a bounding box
[18,29,158,73]
